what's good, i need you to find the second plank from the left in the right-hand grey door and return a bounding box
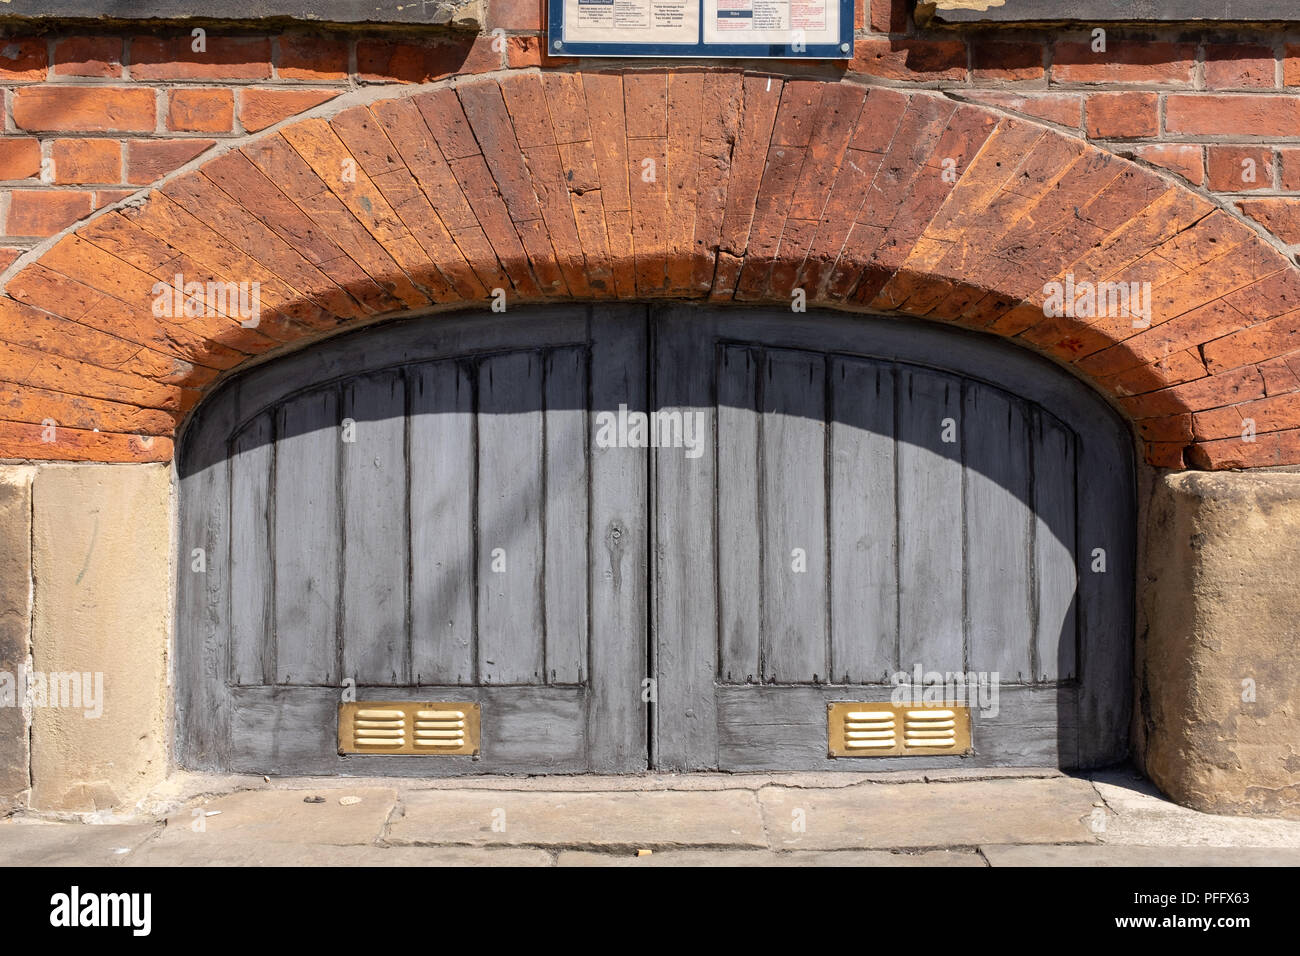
[759,349,829,683]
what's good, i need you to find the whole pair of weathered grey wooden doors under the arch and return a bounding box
[176,306,1134,775]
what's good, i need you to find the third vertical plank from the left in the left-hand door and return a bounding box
[341,372,411,684]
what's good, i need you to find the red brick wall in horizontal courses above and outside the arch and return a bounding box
[0,10,1300,254]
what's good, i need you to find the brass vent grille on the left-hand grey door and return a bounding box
[338,701,481,756]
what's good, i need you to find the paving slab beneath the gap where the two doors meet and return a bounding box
[386,791,767,849]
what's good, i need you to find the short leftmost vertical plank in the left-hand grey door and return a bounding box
[230,412,276,684]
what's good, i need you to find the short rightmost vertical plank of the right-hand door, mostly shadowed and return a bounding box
[1031,411,1079,683]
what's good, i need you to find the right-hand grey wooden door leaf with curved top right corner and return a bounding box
[651,308,1134,770]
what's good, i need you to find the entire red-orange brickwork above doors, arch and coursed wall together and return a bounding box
[0,0,1300,468]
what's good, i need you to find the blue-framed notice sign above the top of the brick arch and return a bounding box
[546,0,853,60]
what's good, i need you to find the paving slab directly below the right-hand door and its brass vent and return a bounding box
[758,777,1097,849]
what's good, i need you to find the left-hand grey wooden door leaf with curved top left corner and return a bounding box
[178,307,647,775]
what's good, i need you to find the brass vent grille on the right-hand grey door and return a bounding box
[826,701,971,757]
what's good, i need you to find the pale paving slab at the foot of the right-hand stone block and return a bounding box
[1092,771,1300,848]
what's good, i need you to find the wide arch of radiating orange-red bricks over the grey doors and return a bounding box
[0,68,1300,468]
